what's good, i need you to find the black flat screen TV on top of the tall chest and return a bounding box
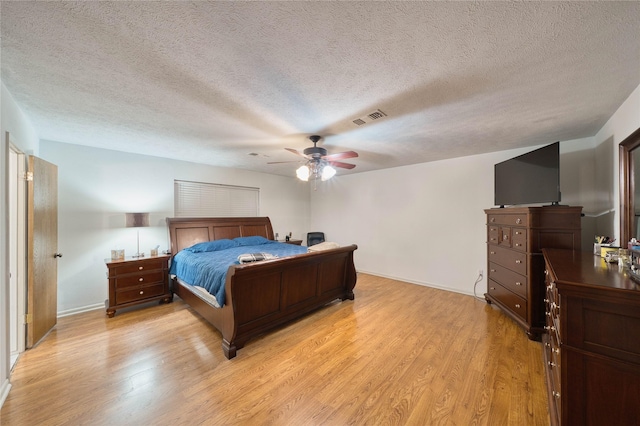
[494,142,560,207]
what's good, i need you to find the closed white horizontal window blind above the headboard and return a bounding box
[173,180,260,217]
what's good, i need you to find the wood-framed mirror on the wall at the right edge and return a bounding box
[618,128,640,247]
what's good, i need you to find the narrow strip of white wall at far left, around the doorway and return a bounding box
[0,82,38,406]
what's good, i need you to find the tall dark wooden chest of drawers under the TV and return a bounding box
[485,206,582,340]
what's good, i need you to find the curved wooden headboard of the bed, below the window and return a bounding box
[167,217,273,254]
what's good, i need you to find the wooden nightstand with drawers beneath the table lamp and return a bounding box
[105,255,173,318]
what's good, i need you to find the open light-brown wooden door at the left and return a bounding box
[27,155,60,348]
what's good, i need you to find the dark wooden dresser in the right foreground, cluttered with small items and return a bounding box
[543,249,640,425]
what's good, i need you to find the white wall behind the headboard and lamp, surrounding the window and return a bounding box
[40,141,309,315]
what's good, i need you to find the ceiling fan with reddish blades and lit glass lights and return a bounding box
[268,135,358,181]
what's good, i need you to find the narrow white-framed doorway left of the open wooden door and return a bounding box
[8,141,27,369]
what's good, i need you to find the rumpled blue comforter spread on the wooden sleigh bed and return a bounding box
[169,236,307,306]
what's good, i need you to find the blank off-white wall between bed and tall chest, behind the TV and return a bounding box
[311,139,594,295]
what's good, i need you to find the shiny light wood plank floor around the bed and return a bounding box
[0,274,549,426]
